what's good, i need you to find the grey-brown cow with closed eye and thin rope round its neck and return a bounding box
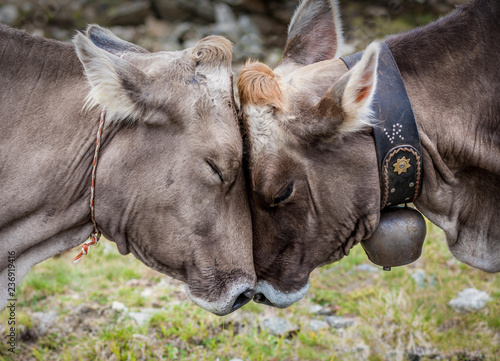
[0,25,256,315]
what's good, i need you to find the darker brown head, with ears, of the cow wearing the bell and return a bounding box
[238,0,380,307]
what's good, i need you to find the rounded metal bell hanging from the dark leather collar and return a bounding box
[361,207,427,270]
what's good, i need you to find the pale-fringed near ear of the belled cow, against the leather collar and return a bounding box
[315,43,380,135]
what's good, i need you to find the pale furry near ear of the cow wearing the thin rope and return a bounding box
[73,33,148,121]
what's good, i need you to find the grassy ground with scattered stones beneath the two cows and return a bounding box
[0,218,500,361]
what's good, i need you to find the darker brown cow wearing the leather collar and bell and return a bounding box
[238,0,500,307]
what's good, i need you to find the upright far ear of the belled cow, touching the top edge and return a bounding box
[281,0,343,65]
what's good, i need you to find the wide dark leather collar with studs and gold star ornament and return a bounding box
[340,43,423,209]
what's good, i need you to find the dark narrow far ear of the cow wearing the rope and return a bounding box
[86,24,149,56]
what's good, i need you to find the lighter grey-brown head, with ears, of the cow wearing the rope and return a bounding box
[74,25,255,315]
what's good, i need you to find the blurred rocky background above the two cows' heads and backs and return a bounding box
[0,0,464,66]
